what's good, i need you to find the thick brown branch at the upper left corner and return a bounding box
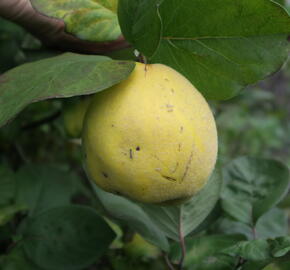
[0,0,130,54]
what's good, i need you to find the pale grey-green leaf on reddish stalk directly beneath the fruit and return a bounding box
[142,171,221,241]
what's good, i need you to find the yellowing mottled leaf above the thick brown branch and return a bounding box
[31,0,121,41]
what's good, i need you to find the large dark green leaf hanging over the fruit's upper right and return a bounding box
[119,0,290,100]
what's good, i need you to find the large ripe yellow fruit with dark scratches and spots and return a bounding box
[83,63,217,204]
